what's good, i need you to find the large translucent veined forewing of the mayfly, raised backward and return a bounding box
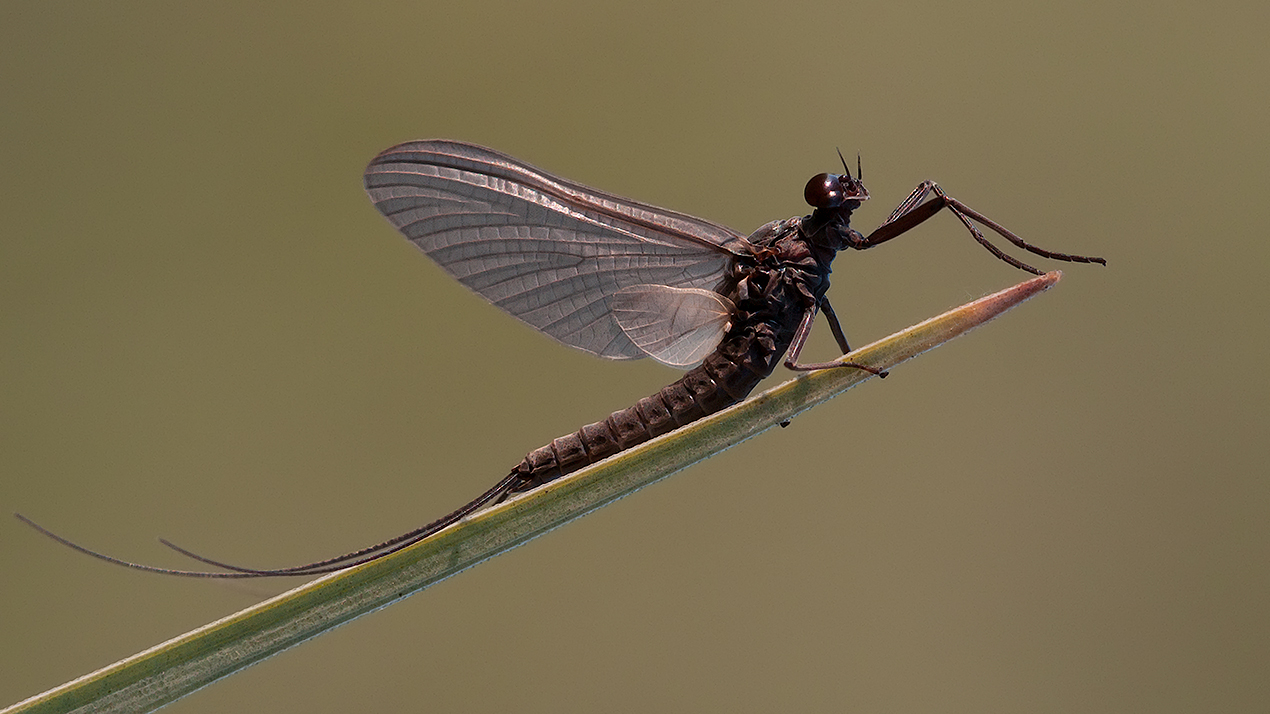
[366,140,749,360]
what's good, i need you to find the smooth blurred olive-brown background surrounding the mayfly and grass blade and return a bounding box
[0,1,1270,713]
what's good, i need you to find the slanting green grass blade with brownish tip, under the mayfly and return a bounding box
[4,272,1060,713]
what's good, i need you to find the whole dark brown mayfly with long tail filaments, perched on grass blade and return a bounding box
[18,140,1106,578]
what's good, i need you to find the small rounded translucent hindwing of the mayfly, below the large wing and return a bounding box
[610,285,735,367]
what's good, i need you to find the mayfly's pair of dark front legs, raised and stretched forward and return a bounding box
[856,180,1106,276]
